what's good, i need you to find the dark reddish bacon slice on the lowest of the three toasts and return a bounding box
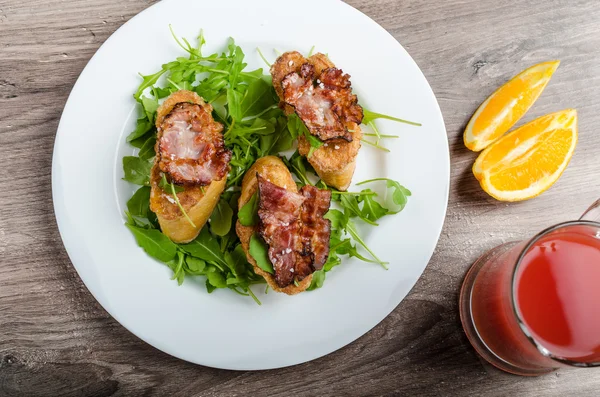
[258,176,331,288]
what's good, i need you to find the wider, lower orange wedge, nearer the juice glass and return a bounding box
[473,109,577,201]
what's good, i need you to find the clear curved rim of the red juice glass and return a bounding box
[511,220,600,367]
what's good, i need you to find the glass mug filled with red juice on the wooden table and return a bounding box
[459,200,600,376]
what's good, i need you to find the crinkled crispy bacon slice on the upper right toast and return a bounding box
[281,63,363,142]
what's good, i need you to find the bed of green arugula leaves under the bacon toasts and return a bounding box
[123,30,410,304]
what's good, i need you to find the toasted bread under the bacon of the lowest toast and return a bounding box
[235,156,312,295]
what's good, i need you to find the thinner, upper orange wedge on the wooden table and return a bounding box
[463,61,560,152]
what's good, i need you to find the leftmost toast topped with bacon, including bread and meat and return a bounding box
[150,90,231,243]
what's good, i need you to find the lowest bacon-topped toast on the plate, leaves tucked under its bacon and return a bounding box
[236,156,331,295]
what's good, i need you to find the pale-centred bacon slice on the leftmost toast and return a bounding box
[157,102,231,185]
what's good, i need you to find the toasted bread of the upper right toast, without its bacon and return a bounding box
[271,51,362,190]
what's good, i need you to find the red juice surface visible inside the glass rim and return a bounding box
[515,226,600,363]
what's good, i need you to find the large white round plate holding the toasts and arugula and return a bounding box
[52,0,449,370]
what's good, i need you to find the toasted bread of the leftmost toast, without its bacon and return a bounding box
[150,90,227,243]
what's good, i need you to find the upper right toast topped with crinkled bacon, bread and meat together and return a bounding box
[271,51,363,190]
